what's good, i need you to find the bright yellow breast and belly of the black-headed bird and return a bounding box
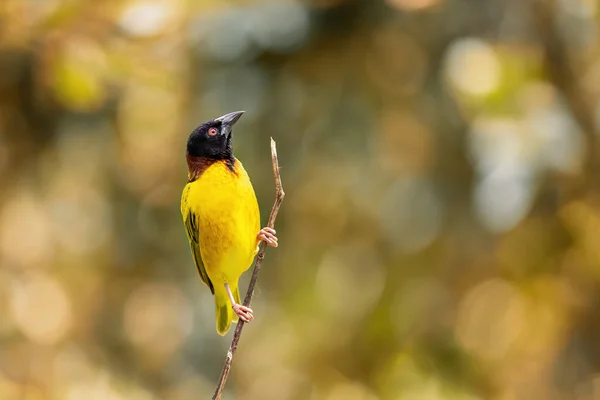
[181,159,260,285]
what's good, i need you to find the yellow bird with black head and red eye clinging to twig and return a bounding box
[181,111,278,336]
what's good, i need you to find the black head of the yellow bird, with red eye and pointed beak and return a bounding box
[187,111,244,160]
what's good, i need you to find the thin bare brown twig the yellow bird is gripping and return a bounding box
[213,138,285,400]
